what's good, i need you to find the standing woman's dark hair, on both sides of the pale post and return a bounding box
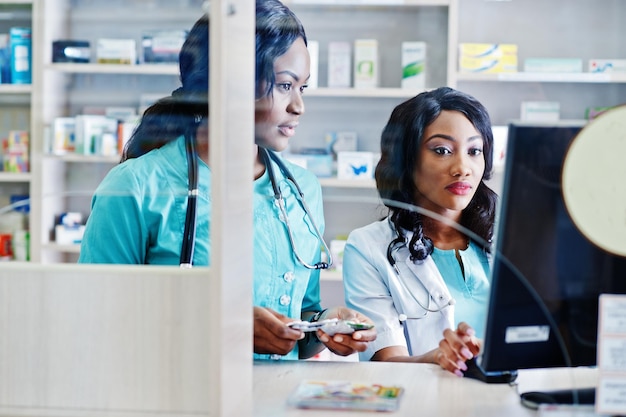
[122,0,307,162]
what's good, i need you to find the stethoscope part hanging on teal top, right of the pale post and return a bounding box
[258,146,333,269]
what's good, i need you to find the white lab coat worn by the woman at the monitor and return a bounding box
[343,219,454,361]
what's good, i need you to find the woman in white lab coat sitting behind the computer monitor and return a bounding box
[343,87,497,376]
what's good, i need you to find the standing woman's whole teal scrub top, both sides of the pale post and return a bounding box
[79,136,324,359]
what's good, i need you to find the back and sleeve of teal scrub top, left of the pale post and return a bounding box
[78,136,211,265]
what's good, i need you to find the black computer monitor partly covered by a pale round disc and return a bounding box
[478,121,626,371]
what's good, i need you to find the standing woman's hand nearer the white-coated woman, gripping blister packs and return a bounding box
[317,307,376,356]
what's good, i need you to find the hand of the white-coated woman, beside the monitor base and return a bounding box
[433,322,480,376]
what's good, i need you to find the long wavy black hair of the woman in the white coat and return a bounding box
[375,87,498,262]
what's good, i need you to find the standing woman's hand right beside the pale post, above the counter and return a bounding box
[254,307,304,355]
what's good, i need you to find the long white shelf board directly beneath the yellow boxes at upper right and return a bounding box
[456,72,626,83]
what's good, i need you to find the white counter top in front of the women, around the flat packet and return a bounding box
[253,361,597,417]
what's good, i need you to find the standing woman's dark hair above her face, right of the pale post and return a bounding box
[255,0,308,99]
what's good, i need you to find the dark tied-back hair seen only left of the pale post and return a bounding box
[121,14,209,162]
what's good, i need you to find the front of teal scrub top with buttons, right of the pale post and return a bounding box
[253,154,324,359]
